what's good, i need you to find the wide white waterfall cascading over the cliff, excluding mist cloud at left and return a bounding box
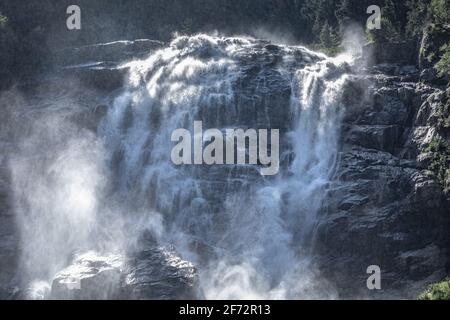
[100,36,352,298]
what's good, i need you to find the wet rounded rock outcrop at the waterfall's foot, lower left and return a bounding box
[49,246,198,300]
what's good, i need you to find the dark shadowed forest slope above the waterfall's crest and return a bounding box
[0,0,450,85]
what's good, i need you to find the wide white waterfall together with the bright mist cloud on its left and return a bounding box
[10,35,352,299]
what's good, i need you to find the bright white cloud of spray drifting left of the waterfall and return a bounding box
[11,116,105,298]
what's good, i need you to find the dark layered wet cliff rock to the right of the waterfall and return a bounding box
[316,66,450,298]
